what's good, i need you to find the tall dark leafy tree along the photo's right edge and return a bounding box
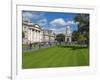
[74,14,89,45]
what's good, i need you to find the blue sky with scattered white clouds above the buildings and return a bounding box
[22,11,77,33]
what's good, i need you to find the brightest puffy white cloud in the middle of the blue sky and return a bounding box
[50,18,66,26]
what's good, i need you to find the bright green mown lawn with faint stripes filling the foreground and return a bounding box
[22,46,89,69]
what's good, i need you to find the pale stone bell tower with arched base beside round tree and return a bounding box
[65,26,72,43]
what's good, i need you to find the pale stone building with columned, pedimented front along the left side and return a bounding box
[22,21,55,44]
